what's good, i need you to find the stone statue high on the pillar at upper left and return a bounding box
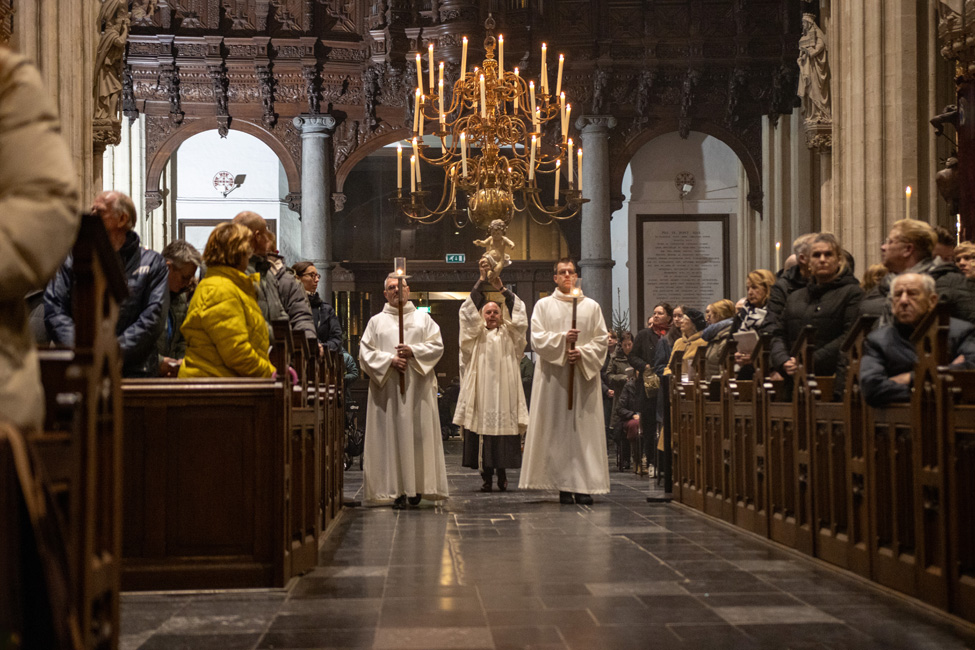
[95,0,129,120]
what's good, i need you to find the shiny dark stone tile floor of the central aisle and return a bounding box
[121,440,975,650]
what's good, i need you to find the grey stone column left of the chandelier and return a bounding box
[293,115,335,304]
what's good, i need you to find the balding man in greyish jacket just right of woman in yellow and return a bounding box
[234,211,318,342]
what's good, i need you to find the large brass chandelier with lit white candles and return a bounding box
[393,14,588,229]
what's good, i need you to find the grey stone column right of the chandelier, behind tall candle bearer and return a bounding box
[576,115,616,327]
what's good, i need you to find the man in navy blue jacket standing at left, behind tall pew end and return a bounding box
[44,190,169,377]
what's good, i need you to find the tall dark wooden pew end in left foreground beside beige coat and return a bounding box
[34,214,128,648]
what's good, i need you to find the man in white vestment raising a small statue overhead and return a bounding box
[454,258,528,492]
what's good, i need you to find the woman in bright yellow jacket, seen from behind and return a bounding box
[179,223,274,377]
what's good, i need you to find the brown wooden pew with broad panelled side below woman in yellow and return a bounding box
[123,323,331,590]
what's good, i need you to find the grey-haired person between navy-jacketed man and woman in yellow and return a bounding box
[156,239,203,377]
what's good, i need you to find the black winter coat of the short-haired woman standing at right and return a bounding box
[772,270,863,375]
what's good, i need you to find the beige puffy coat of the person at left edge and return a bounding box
[0,48,80,428]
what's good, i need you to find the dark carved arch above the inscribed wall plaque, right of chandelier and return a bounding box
[610,119,763,214]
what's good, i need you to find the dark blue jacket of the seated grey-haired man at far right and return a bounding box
[860,318,975,407]
